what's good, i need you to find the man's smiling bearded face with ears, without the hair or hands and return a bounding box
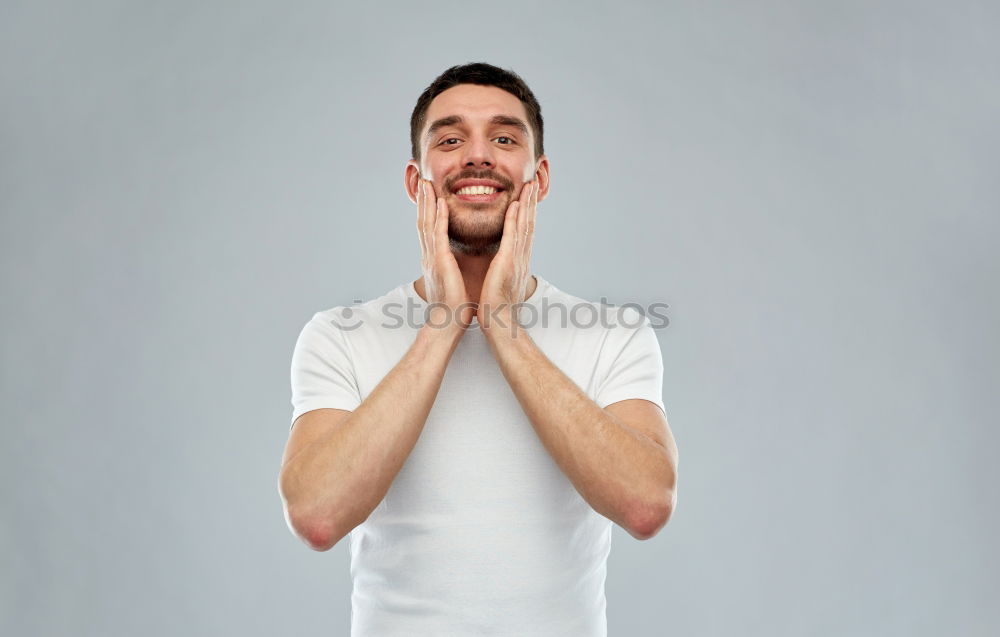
[407,84,548,256]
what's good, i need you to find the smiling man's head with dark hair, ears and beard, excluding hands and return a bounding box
[405,63,549,256]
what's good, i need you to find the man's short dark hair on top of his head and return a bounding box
[410,62,545,160]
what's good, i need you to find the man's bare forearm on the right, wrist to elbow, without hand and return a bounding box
[490,328,673,532]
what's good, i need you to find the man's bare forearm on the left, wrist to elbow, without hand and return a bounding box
[282,325,461,543]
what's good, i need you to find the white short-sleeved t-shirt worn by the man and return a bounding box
[291,275,664,637]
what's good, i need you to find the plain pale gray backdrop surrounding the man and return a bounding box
[0,0,1000,636]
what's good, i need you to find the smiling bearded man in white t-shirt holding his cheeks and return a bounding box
[280,64,677,637]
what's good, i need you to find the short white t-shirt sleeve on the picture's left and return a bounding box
[289,313,361,429]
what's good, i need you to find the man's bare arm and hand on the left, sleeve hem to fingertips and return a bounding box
[278,179,473,551]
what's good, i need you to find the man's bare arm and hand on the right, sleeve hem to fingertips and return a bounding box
[477,179,677,540]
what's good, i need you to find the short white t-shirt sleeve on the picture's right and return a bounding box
[594,310,666,414]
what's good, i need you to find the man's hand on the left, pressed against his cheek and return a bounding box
[417,178,476,329]
